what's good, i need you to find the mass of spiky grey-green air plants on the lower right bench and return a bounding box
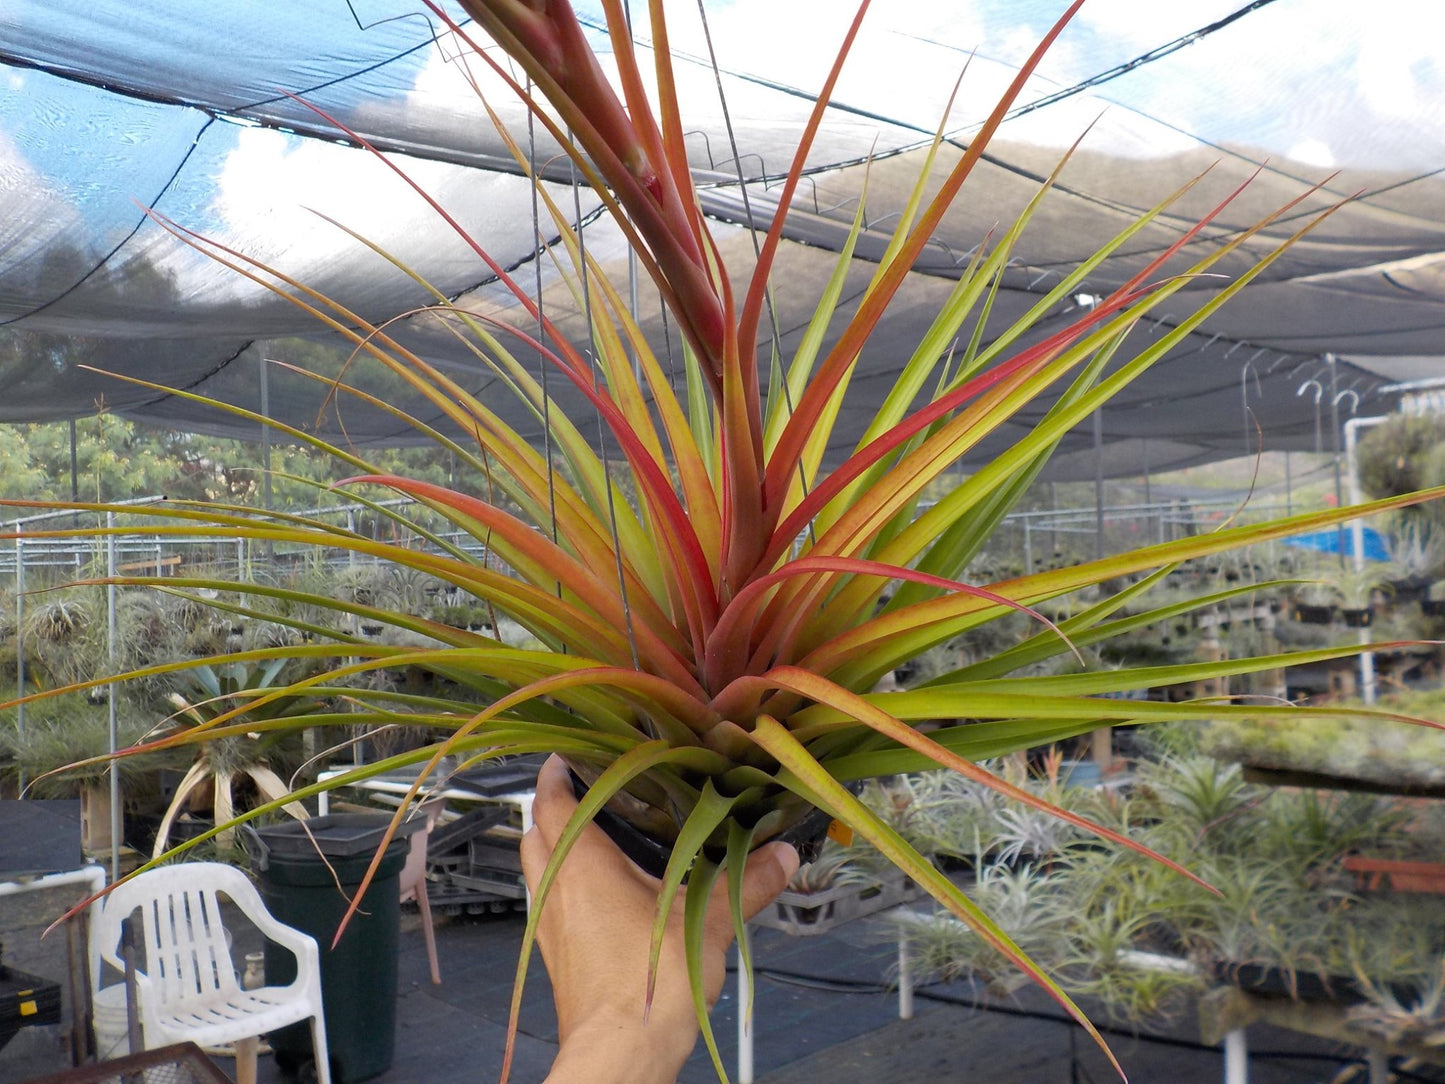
[906,744,1445,1023]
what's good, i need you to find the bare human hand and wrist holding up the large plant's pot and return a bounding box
[522,756,798,1084]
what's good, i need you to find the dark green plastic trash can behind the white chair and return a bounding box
[249,814,426,1084]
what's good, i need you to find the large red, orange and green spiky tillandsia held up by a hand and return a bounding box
[16,0,1439,1075]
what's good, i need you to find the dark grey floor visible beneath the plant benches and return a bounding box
[0,890,1387,1084]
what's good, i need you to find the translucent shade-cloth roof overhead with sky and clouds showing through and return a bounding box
[0,0,1445,477]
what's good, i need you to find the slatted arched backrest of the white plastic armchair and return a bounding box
[94,861,252,1005]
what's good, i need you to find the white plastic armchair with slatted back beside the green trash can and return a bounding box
[91,861,331,1084]
